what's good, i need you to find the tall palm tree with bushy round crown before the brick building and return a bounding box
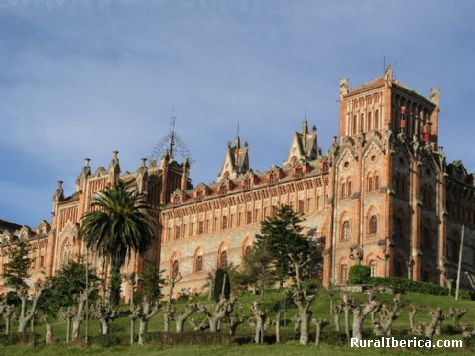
[81,183,155,305]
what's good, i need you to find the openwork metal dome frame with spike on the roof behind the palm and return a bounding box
[150,109,193,163]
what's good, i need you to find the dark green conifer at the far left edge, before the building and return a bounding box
[3,241,31,291]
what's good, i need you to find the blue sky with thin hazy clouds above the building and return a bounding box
[0,0,475,226]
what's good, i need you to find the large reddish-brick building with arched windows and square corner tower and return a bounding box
[0,67,475,290]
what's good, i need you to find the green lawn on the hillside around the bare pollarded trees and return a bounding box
[0,291,475,356]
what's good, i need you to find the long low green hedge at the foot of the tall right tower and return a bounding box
[368,276,475,300]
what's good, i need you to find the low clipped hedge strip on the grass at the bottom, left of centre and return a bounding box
[146,331,234,346]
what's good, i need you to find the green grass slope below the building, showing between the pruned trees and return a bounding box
[0,291,475,355]
